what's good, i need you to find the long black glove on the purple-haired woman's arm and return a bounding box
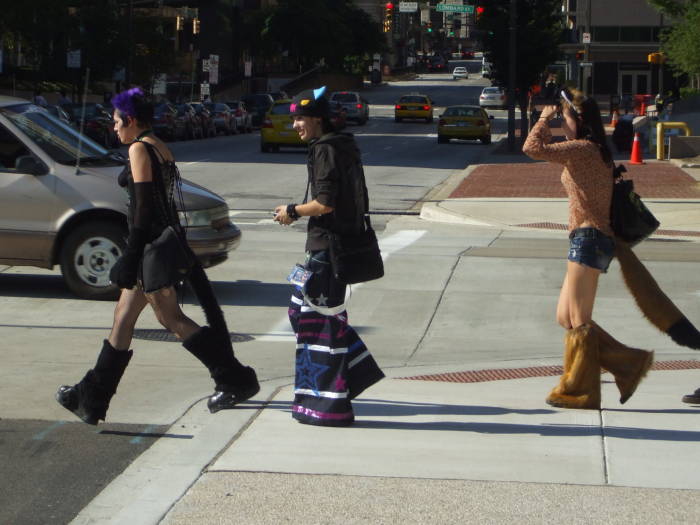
[109,182,153,288]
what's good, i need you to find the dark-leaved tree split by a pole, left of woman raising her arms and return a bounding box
[476,0,563,137]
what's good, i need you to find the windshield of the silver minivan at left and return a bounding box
[0,103,121,166]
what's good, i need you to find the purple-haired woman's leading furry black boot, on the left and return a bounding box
[56,339,134,425]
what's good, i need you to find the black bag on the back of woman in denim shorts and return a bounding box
[610,166,659,246]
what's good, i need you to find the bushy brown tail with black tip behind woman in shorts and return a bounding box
[615,238,700,350]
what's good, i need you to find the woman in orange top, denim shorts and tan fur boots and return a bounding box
[523,90,653,409]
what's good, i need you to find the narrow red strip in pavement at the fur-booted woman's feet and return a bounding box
[398,361,700,383]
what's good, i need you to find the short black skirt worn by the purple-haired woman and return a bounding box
[142,226,196,292]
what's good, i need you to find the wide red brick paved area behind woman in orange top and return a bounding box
[450,162,700,199]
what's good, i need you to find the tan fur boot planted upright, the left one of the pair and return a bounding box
[546,324,600,410]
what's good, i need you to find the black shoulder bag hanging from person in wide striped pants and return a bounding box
[328,215,384,284]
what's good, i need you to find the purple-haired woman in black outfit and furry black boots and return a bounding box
[56,88,260,425]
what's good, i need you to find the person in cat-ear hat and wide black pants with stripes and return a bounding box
[274,87,384,426]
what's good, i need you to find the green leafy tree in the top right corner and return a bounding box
[661,2,700,89]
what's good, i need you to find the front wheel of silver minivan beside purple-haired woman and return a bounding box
[60,221,127,300]
